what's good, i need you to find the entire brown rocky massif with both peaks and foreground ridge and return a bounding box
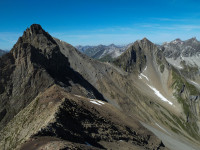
[0,24,200,150]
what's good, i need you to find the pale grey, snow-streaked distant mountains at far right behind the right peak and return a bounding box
[160,38,200,78]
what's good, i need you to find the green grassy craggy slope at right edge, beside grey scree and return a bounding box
[171,69,200,139]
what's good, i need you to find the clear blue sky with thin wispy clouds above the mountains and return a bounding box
[0,0,200,49]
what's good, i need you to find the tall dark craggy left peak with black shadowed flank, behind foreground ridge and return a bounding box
[0,25,103,128]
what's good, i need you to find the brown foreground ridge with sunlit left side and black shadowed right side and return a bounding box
[0,86,165,149]
